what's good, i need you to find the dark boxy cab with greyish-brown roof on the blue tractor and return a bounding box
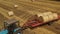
[4,19,20,29]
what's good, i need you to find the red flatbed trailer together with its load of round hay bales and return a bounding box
[23,12,60,28]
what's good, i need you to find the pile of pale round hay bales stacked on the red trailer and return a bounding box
[37,12,58,23]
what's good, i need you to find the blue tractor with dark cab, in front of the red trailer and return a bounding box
[0,19,21,34]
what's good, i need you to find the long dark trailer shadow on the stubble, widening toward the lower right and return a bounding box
[31,21,60,34]
